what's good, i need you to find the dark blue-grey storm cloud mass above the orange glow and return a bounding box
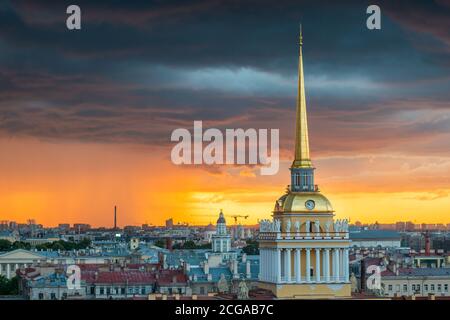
[0,0,450,158]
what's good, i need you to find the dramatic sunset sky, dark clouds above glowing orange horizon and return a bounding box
[0,0,450,226]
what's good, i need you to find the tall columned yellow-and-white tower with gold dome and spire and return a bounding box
[259,30,351,299]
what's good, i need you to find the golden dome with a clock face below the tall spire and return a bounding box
[274,192,334,213]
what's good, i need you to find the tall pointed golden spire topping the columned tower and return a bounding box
[292,25,312,168]
